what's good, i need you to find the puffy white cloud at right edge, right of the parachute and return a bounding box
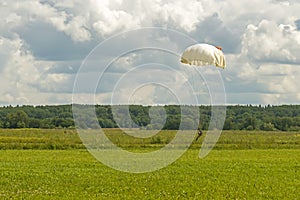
[242,20,300,62]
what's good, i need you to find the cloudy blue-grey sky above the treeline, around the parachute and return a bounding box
[0,0,300,105]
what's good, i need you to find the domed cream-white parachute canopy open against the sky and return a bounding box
[181,44,226,68]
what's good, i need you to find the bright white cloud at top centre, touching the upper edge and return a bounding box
[91,0,210,35]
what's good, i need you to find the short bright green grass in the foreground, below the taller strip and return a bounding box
[0,149,300,199]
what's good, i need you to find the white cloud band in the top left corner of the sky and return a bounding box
[0,0,91,42]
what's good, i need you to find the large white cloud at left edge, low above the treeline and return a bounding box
[0,35,69,104]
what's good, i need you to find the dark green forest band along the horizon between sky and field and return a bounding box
[0,105,300,131]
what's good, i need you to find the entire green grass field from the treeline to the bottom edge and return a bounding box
[0,130,300,199]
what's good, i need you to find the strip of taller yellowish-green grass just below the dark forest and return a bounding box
[0,129,300,150]
